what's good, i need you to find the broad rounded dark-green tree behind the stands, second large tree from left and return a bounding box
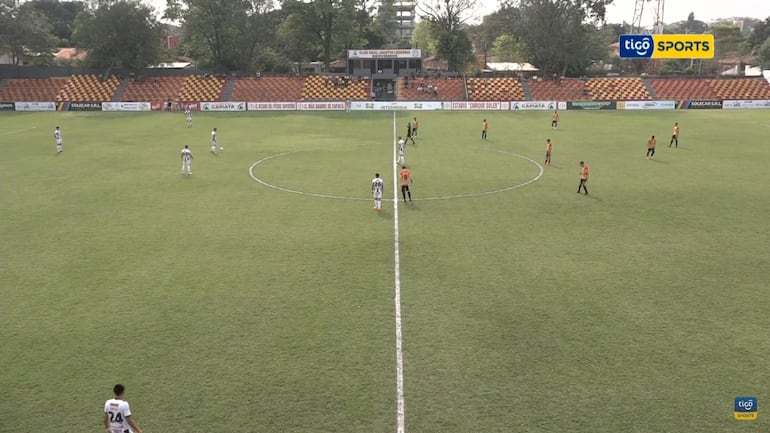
[72,1,161,69]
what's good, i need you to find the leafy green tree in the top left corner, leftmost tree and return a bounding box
[0,0,56,65]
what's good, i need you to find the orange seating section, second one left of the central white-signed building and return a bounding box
[231,77,305,102]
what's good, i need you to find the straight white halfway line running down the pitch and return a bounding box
[393,111,406,433]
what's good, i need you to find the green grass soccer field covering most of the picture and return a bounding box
[0,110,770,433]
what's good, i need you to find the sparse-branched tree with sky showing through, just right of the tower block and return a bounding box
[419,0,476,71]
